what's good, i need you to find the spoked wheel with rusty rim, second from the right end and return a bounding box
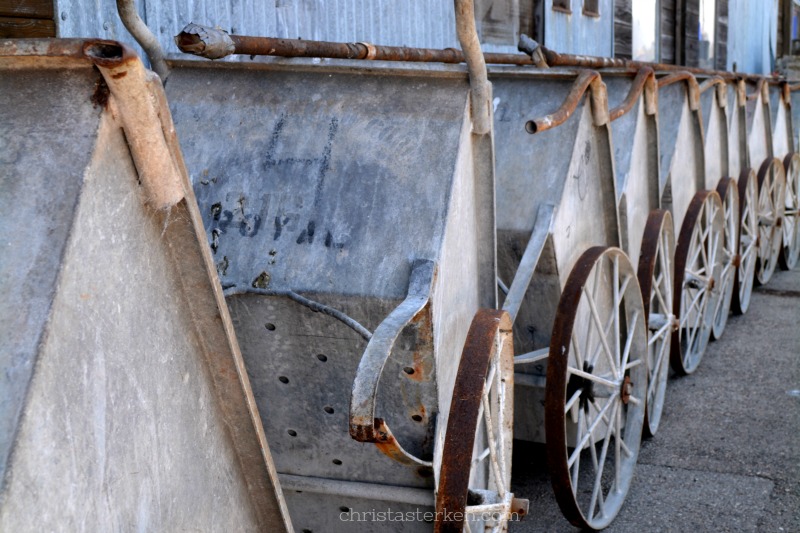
[756,159,786,285]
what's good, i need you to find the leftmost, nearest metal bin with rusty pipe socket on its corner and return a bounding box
[0,40,290,531]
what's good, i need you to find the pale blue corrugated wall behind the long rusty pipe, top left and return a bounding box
[56,0,532,64]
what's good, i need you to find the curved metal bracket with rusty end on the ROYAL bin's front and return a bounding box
[350,260,436,467]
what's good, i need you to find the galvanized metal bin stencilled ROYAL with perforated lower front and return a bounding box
[162,53,510,531]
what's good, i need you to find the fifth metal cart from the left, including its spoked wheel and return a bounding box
[658,72,724,374]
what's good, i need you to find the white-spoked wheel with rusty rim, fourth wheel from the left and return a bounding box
[670,191,725,375]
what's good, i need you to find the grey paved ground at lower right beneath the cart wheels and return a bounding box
[510,269,800,533]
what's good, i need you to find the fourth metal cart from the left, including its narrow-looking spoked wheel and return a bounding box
[602,68,677,436]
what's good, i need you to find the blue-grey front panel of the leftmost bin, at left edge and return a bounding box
[0,64,100,480]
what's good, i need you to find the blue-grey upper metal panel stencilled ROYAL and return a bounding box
[167,62,467,298]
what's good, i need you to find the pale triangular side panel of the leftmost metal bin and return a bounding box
[0,110,258,531]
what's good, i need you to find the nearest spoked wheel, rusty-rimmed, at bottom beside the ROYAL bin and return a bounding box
[435,309,527,533]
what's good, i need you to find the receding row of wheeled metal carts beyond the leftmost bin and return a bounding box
[1,9,800,532]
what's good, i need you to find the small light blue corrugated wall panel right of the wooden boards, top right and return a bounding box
[544,0,614,57]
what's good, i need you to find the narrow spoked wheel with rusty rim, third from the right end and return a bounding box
[731,169,758,315]
